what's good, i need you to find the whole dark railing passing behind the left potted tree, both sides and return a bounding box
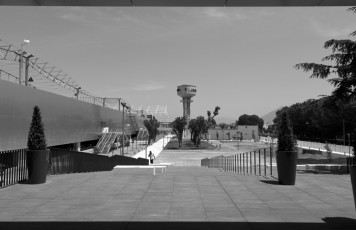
[0,148,148,188]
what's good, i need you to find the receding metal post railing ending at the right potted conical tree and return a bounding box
[201,147,276,177]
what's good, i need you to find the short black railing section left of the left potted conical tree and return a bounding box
[0,149,28,188]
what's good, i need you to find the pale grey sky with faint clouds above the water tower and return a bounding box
[0,6,356,122]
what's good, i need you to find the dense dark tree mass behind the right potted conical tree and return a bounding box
[271,96,356,144]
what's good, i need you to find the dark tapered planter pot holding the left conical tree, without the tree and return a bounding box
[27,149,49,184]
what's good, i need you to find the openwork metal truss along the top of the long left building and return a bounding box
[0,38,128,109]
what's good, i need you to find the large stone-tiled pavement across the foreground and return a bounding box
[0,166,356,230]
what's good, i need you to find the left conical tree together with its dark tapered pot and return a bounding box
[27,106,49,184]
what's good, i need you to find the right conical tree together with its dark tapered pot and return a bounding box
[276,111,298,185]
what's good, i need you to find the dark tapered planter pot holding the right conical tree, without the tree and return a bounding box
[276,151,298,185]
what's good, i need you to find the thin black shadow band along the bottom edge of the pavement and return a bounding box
[0,220,356,230]
